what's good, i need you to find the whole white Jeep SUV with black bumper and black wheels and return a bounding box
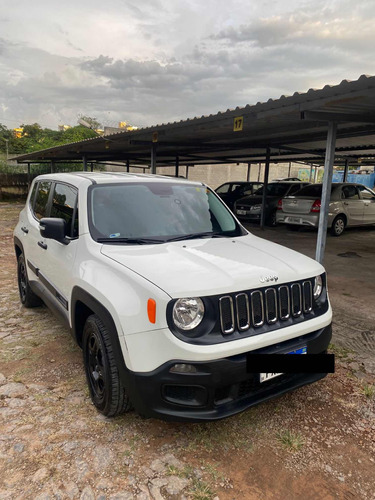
[14,172,332,421]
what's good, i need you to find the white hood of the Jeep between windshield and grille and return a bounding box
[101,234,324,298]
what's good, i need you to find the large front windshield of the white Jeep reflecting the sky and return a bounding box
[88,182,245,243]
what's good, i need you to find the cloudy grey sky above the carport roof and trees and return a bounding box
[0,0,375,128]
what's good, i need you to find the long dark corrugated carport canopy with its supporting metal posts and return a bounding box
[15,75,375,262]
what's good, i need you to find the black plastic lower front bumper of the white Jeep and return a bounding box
[125,325,332,422]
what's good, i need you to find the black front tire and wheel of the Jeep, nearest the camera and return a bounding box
[82,314,131,417]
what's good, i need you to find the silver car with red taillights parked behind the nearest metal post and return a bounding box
[276,183,375,236]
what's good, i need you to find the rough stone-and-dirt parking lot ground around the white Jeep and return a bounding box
[0,204,375,500]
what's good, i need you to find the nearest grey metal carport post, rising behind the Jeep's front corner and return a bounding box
[315,122,337,264]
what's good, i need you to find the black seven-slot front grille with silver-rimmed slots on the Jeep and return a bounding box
[219,280,313,335]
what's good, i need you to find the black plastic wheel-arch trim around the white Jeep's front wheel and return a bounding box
[71,286,145,409]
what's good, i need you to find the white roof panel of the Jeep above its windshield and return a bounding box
[36,171,205,186]
